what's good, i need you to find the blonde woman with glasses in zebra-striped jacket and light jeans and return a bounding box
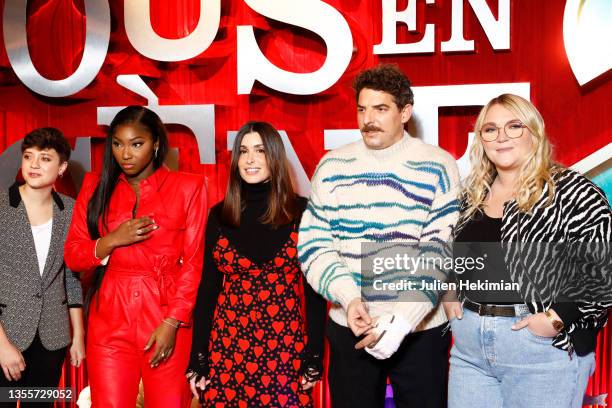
[444,94,612,408]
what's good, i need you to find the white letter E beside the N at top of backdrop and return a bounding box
[374,0,435,54]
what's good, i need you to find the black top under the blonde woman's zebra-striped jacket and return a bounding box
[454,211,523,305]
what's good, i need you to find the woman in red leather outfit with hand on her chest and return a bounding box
[65,106,206,408]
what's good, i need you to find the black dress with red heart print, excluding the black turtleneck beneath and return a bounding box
[204,231,312,407]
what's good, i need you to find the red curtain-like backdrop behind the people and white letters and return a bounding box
[0,0,612,407]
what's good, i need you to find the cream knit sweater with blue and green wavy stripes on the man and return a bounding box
[298,134,459,330]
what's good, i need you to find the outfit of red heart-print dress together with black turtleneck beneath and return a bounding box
[189,183,326,408]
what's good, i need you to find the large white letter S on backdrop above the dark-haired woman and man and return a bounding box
[237,0,353,95]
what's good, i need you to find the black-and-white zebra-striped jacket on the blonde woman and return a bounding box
[455,168,612,355]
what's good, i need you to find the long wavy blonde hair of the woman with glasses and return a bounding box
[460,94,557,223]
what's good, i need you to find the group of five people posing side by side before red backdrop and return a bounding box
[0,65,612,408]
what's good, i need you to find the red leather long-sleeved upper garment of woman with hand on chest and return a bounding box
[64,167,207,323]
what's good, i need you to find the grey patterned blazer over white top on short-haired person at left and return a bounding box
[0,183,83,351]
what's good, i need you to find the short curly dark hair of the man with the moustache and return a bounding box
[353,64,414,109]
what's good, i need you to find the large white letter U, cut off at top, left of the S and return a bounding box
[123,0,221,61]
